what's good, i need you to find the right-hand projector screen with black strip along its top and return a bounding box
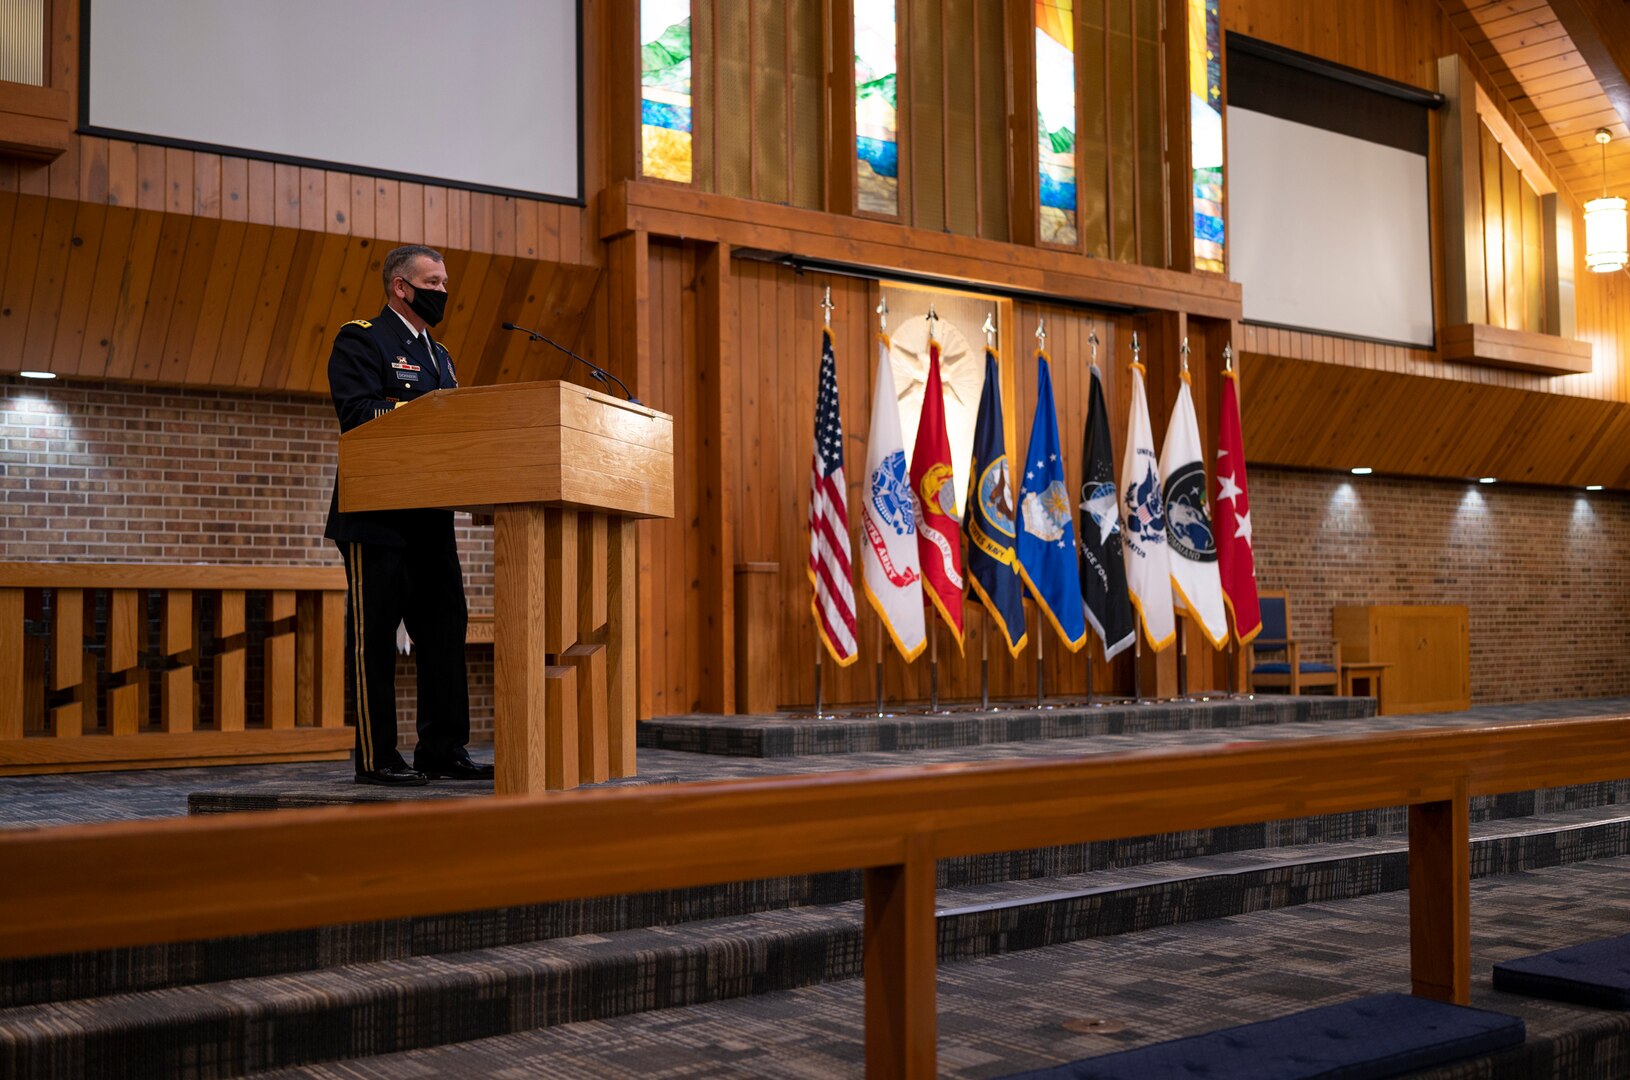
[1227,36,1433,349]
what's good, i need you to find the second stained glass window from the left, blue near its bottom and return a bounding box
[854,0,900,215]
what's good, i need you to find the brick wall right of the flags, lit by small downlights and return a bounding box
[1250,466,1630,704]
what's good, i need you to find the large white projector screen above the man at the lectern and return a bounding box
[82,0,582,202]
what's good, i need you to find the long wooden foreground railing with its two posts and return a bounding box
[0,717,1630,1077]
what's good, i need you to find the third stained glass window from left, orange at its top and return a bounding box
[1035,0,1076,248]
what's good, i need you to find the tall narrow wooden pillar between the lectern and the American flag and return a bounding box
[694,244,740,713]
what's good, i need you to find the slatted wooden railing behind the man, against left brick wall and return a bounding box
[0,562,352,775]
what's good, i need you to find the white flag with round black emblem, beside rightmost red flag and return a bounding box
[1161,371,1227,648]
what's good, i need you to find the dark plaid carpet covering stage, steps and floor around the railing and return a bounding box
[0,699,1630,1080]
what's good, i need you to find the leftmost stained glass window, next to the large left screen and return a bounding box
[639,0,691,184]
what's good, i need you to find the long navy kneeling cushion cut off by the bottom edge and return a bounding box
[1007,994,1526,1080]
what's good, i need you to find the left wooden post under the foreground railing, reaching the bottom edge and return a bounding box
[864,837,937,1080]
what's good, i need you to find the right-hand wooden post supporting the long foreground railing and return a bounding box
[1410,777,1472,1005]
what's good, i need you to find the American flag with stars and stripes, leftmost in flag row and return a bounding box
[810,331,857,665]
